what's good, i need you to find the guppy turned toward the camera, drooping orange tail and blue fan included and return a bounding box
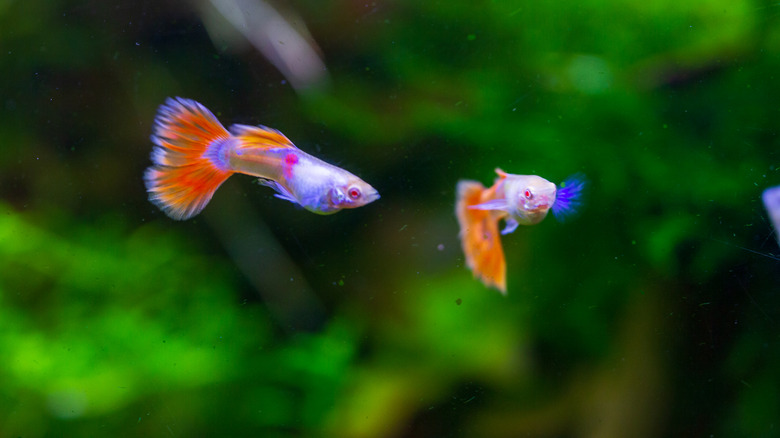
[455,169,585,294]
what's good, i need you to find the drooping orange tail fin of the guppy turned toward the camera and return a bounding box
[455,181,506,294]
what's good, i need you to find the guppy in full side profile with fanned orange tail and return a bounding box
[144,97,379,220]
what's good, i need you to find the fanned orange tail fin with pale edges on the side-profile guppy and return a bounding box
[144,97,233,220]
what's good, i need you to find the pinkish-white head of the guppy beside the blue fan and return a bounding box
[504,175,557,225]
